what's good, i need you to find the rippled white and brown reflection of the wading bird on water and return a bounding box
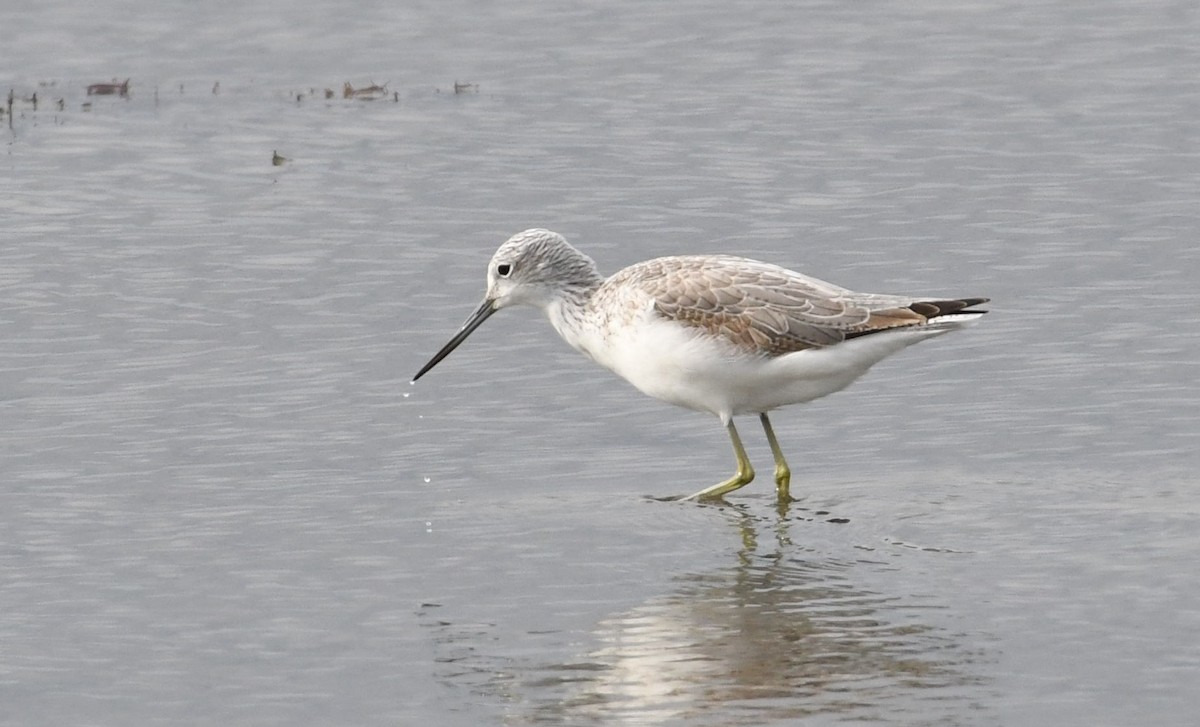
[427,510,974,725]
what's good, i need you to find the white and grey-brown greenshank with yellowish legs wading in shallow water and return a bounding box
[413,229,988,503]
